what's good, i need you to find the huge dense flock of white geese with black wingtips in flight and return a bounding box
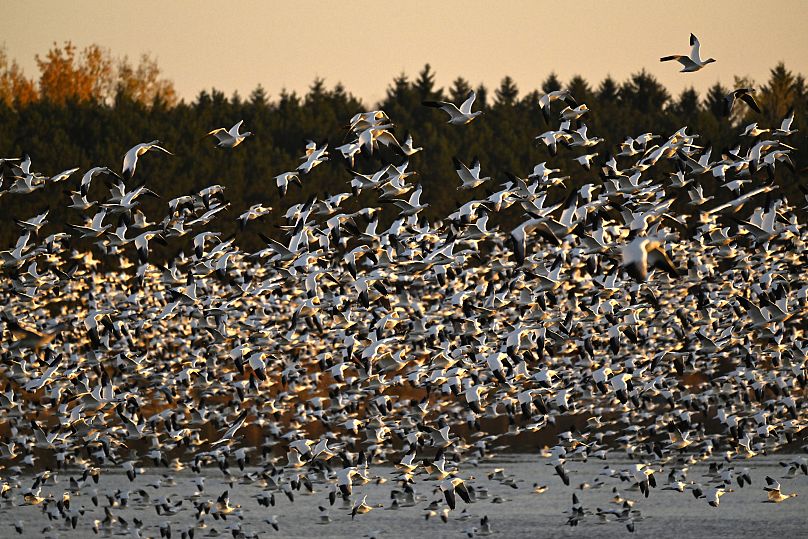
[0,36,808,538]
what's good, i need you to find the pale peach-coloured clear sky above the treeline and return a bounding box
[0,0,808,105]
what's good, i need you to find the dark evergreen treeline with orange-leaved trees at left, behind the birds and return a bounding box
[0,43,808,256]
